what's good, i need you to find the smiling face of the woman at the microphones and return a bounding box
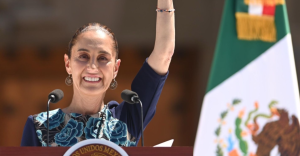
[65,30,121,95]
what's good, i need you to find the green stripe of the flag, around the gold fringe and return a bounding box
[206,0,290,92]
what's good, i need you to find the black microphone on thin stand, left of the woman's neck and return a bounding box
[47,89,64,147]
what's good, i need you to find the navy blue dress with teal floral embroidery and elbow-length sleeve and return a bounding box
[21,61,168,146]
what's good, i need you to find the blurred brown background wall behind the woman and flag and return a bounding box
[0,0,300,146]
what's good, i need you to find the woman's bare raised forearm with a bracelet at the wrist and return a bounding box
[148,0,175,75]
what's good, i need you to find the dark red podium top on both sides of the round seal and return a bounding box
[0,147,193,156]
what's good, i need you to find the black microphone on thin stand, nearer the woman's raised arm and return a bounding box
[121,89,144,147]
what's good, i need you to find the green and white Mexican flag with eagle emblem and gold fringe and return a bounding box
[194,0,300,156]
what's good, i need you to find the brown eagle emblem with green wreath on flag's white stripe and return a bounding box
[215,99,300,156]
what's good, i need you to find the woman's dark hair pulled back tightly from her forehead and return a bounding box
[68,23,119,59]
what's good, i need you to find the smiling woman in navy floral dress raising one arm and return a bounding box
[21,0,175,146]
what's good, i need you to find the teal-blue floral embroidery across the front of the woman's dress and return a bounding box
[33,105,136,146]
